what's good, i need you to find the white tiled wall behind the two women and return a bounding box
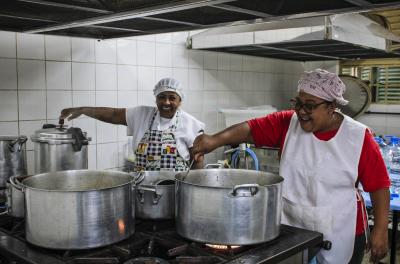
[0,31,382,173]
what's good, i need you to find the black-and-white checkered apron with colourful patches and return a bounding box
[135,111,188,171]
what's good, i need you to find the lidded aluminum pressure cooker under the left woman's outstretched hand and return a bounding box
[31,124,91,173]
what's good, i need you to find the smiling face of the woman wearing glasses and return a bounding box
[294,91,340,132]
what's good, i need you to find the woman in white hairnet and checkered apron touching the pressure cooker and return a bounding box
[60,78,204,171]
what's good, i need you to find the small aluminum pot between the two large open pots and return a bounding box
[136,171,177,219]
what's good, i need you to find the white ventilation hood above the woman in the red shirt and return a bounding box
[188,14,400,61]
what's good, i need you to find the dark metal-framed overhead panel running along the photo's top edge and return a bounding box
[0,0,400,39]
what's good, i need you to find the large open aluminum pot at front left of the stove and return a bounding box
[22,170,135,249]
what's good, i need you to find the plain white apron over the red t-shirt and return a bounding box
[279,113,366,264]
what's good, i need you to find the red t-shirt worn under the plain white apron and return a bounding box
[247,111,390,235]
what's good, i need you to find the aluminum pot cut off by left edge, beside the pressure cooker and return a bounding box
[0,136,28,195]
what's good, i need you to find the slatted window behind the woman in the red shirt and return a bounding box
[340,59,400,104]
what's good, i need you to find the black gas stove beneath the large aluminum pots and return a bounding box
[0,216,323,264]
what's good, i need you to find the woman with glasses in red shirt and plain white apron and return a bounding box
[193,69,390,264]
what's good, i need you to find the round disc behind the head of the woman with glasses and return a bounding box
[339,75,372,119]
